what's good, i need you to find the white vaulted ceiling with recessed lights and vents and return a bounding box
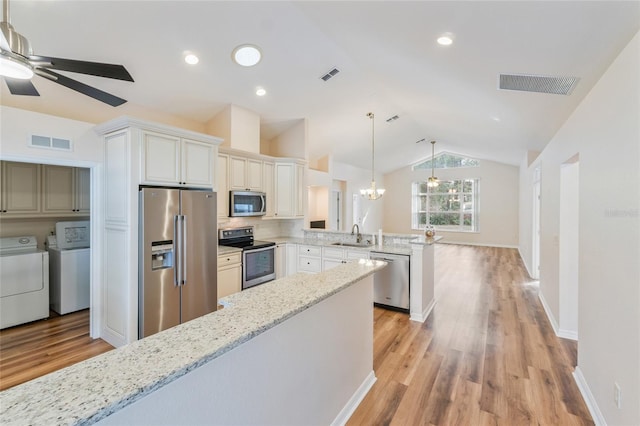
[1,0,640,172]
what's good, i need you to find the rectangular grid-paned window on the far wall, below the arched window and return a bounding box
[411,179,478,232]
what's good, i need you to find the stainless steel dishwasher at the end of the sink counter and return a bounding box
[371,252,410,312]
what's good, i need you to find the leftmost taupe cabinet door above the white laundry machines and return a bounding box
[1,161,41,215]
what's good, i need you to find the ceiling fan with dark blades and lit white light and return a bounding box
[0,0,133,107]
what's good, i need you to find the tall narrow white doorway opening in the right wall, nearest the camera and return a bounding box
[558,155,580,340]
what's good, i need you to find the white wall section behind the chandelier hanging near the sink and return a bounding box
[331,161,382,234]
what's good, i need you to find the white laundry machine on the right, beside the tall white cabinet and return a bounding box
[47,221,91,315]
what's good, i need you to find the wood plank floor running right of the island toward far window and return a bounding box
[348,244,593,425]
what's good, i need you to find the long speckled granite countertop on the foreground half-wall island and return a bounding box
[0,260,386,425]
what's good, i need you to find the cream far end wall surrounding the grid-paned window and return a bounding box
[383,160,519,247]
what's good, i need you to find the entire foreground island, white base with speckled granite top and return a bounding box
[0,260,385,425]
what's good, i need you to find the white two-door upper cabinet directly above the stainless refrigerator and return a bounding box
[141,131,216,188]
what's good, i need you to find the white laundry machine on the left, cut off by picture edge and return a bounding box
[0,236,49,328]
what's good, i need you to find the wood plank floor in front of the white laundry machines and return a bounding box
[0,309,113,390]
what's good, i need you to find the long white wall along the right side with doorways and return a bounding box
[520,30,640,425]
